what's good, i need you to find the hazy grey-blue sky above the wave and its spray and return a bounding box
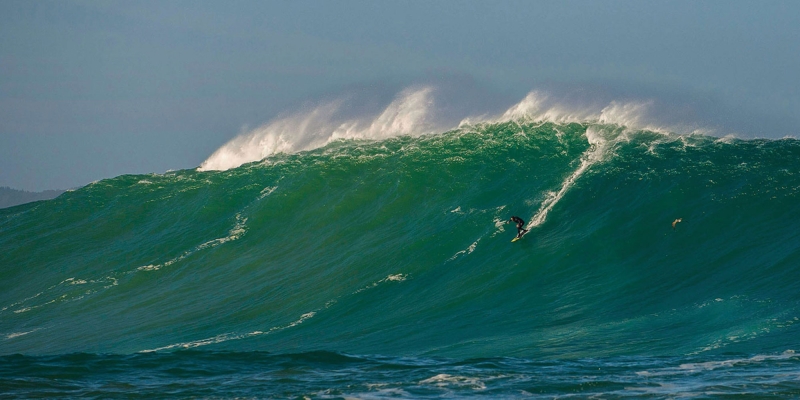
[0,0,800,191]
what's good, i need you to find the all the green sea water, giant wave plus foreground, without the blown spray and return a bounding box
[0,98,800,399]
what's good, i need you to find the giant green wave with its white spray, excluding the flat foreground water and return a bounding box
[0,100,800,358]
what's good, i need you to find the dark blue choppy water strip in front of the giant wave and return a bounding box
[0,351,800,399]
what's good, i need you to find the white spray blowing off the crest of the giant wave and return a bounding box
[202,86,709,171]
